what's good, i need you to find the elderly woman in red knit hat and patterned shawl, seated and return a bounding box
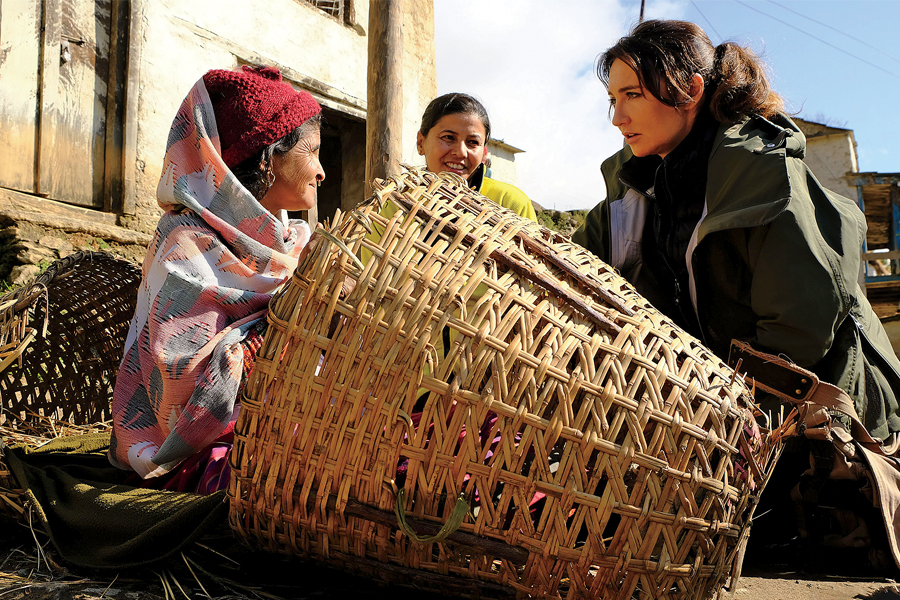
[109,67,325,492]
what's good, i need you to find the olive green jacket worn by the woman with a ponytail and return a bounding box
[572,115,900,438]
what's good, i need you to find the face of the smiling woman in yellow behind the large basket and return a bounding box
[416,113,486,181]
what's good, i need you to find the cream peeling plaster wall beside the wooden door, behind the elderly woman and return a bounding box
[0,0,437,284]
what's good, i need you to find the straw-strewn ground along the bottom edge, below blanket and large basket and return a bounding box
[0,524,900,600]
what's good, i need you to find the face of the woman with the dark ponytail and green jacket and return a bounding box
[607,59,696,158]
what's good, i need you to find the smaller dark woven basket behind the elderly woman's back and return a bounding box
[0,252,141,429]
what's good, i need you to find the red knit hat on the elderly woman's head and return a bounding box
[203,66,322,167]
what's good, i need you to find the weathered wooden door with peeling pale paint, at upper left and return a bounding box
[0,0,121,209]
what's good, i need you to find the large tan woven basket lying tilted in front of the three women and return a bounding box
[229,172,778,599]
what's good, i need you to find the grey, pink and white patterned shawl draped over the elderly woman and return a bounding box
[109,79,310,478]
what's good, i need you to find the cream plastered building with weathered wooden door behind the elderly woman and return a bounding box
[0,0,436,283]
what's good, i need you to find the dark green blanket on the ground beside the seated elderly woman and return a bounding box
[0,434,228,569]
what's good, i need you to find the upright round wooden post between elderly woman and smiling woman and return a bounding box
[366,0,403,196]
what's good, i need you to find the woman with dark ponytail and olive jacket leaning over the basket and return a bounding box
[573,20,900,568]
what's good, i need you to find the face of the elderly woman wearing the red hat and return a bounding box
[260,130,325,214]
